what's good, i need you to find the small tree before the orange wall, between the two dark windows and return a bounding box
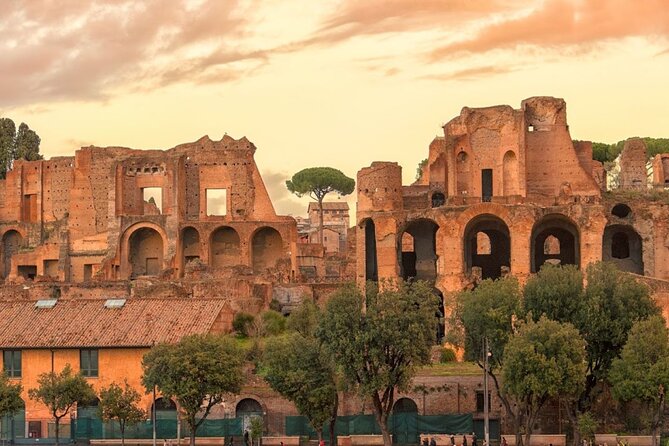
[28,364,96,445]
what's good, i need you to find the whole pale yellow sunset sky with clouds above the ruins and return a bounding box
[0,0,669,215]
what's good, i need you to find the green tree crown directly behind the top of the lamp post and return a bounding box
[449,277,521,368]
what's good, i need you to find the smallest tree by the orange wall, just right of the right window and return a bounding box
[98,380,146,445]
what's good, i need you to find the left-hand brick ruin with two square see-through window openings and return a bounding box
[0,135,297,314]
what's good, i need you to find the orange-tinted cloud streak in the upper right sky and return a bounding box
[430,0,669,61]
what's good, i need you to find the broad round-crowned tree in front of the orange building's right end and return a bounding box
[142,334,244,446]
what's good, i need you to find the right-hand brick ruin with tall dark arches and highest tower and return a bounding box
[356,97,669,308]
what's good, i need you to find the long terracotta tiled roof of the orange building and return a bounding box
[0,299,226,348]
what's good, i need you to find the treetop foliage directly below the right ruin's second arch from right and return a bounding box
[523,264,583,323]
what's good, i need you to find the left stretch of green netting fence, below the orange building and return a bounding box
[73,417,243,440]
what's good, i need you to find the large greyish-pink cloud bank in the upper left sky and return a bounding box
[0,0,266,106]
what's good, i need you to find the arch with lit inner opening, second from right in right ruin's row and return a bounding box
[530,214,580,273]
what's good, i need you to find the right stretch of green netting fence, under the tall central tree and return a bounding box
[286,413,474,444]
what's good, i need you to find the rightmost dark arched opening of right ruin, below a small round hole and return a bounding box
[602,225,644,275]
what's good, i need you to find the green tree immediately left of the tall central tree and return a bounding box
[262,300,339,444]
